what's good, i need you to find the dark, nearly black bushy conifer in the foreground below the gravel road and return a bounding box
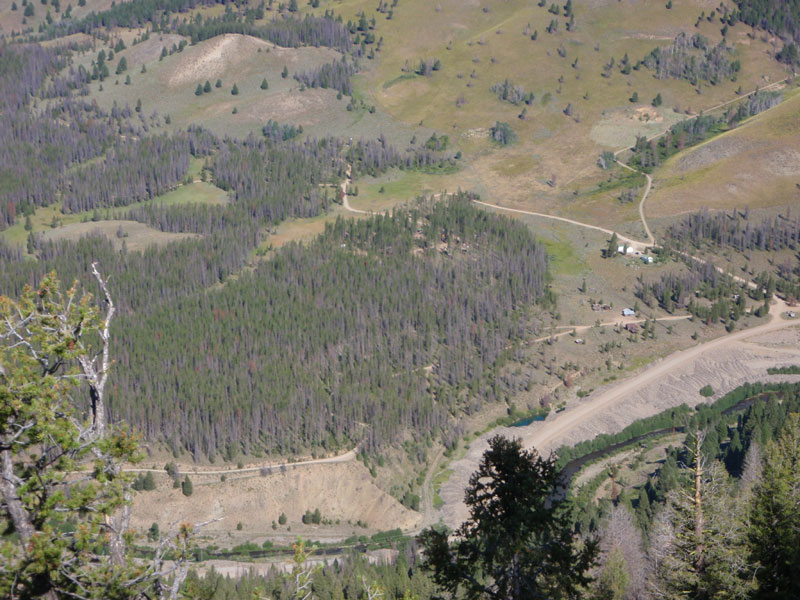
[419,436,597,600]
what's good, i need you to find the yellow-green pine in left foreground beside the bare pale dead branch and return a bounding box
[0,274,194,599]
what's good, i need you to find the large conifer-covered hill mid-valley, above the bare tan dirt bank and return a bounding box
[111,197,547,457]
